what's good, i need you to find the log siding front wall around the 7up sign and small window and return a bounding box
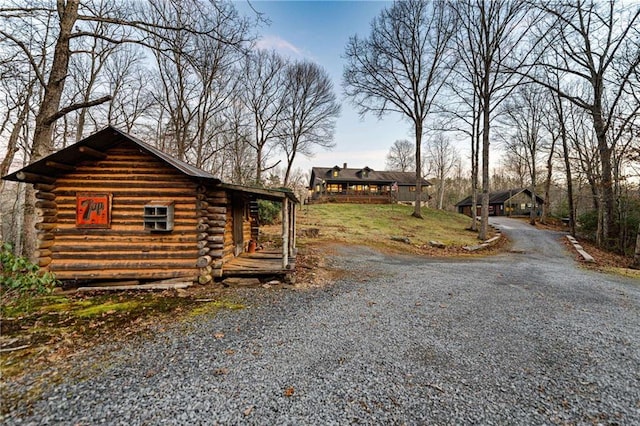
[47,143,199,280]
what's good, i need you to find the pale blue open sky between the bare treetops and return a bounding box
[236,0,413,173]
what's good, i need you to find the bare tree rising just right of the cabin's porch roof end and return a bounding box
[279,61,340,186]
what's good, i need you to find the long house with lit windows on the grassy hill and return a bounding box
[309,163,431,204]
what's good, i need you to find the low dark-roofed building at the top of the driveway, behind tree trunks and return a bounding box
[456,188,544,217]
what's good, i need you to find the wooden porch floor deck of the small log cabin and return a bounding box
[222,250,295,277]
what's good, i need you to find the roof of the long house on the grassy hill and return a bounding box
[310,166,431,188]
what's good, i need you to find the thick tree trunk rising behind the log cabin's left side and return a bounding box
[22,0,79,259]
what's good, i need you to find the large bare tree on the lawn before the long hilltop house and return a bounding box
[343,0,455,218]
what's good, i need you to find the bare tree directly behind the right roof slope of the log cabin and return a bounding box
[149,0,249,167]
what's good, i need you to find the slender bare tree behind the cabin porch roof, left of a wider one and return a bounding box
[242,50,287,183]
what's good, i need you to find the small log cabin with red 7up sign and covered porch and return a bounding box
[3,126,298,284]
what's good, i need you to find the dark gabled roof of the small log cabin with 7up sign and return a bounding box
[2,126,298,203]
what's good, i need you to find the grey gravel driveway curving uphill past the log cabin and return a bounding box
[4,219,640,425]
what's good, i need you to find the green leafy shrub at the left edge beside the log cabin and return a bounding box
[0,243,58,302]
